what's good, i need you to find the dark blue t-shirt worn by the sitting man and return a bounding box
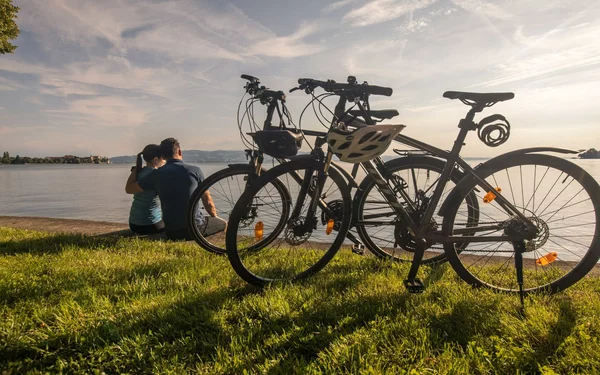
[138,159,204,232]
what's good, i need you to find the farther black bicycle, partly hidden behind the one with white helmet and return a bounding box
[187,75,478,264]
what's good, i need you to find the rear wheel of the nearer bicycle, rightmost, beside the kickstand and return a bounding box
[442,154,600,293]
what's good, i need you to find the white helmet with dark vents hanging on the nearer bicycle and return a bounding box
[327,125,406,163]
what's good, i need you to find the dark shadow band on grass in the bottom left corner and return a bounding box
[0,289,243,373]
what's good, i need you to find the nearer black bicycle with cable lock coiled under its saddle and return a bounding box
[226,79,600,303]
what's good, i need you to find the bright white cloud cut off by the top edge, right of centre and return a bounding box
[344,0,436,26]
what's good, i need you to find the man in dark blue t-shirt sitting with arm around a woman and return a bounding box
[125,138,227,240]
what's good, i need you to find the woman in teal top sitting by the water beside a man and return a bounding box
[129,145,165,235]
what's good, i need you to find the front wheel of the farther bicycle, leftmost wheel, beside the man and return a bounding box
[187,164,290,255]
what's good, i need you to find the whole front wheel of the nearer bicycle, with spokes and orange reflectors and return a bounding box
[226,159,351,286]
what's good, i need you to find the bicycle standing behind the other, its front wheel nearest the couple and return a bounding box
[187,75,477,264]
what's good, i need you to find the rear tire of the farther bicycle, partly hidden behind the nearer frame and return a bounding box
[352,156,479,265]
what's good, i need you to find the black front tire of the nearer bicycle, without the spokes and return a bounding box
[226,159,352,287]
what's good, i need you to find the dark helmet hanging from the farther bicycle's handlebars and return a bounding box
[252,129,303,158]
